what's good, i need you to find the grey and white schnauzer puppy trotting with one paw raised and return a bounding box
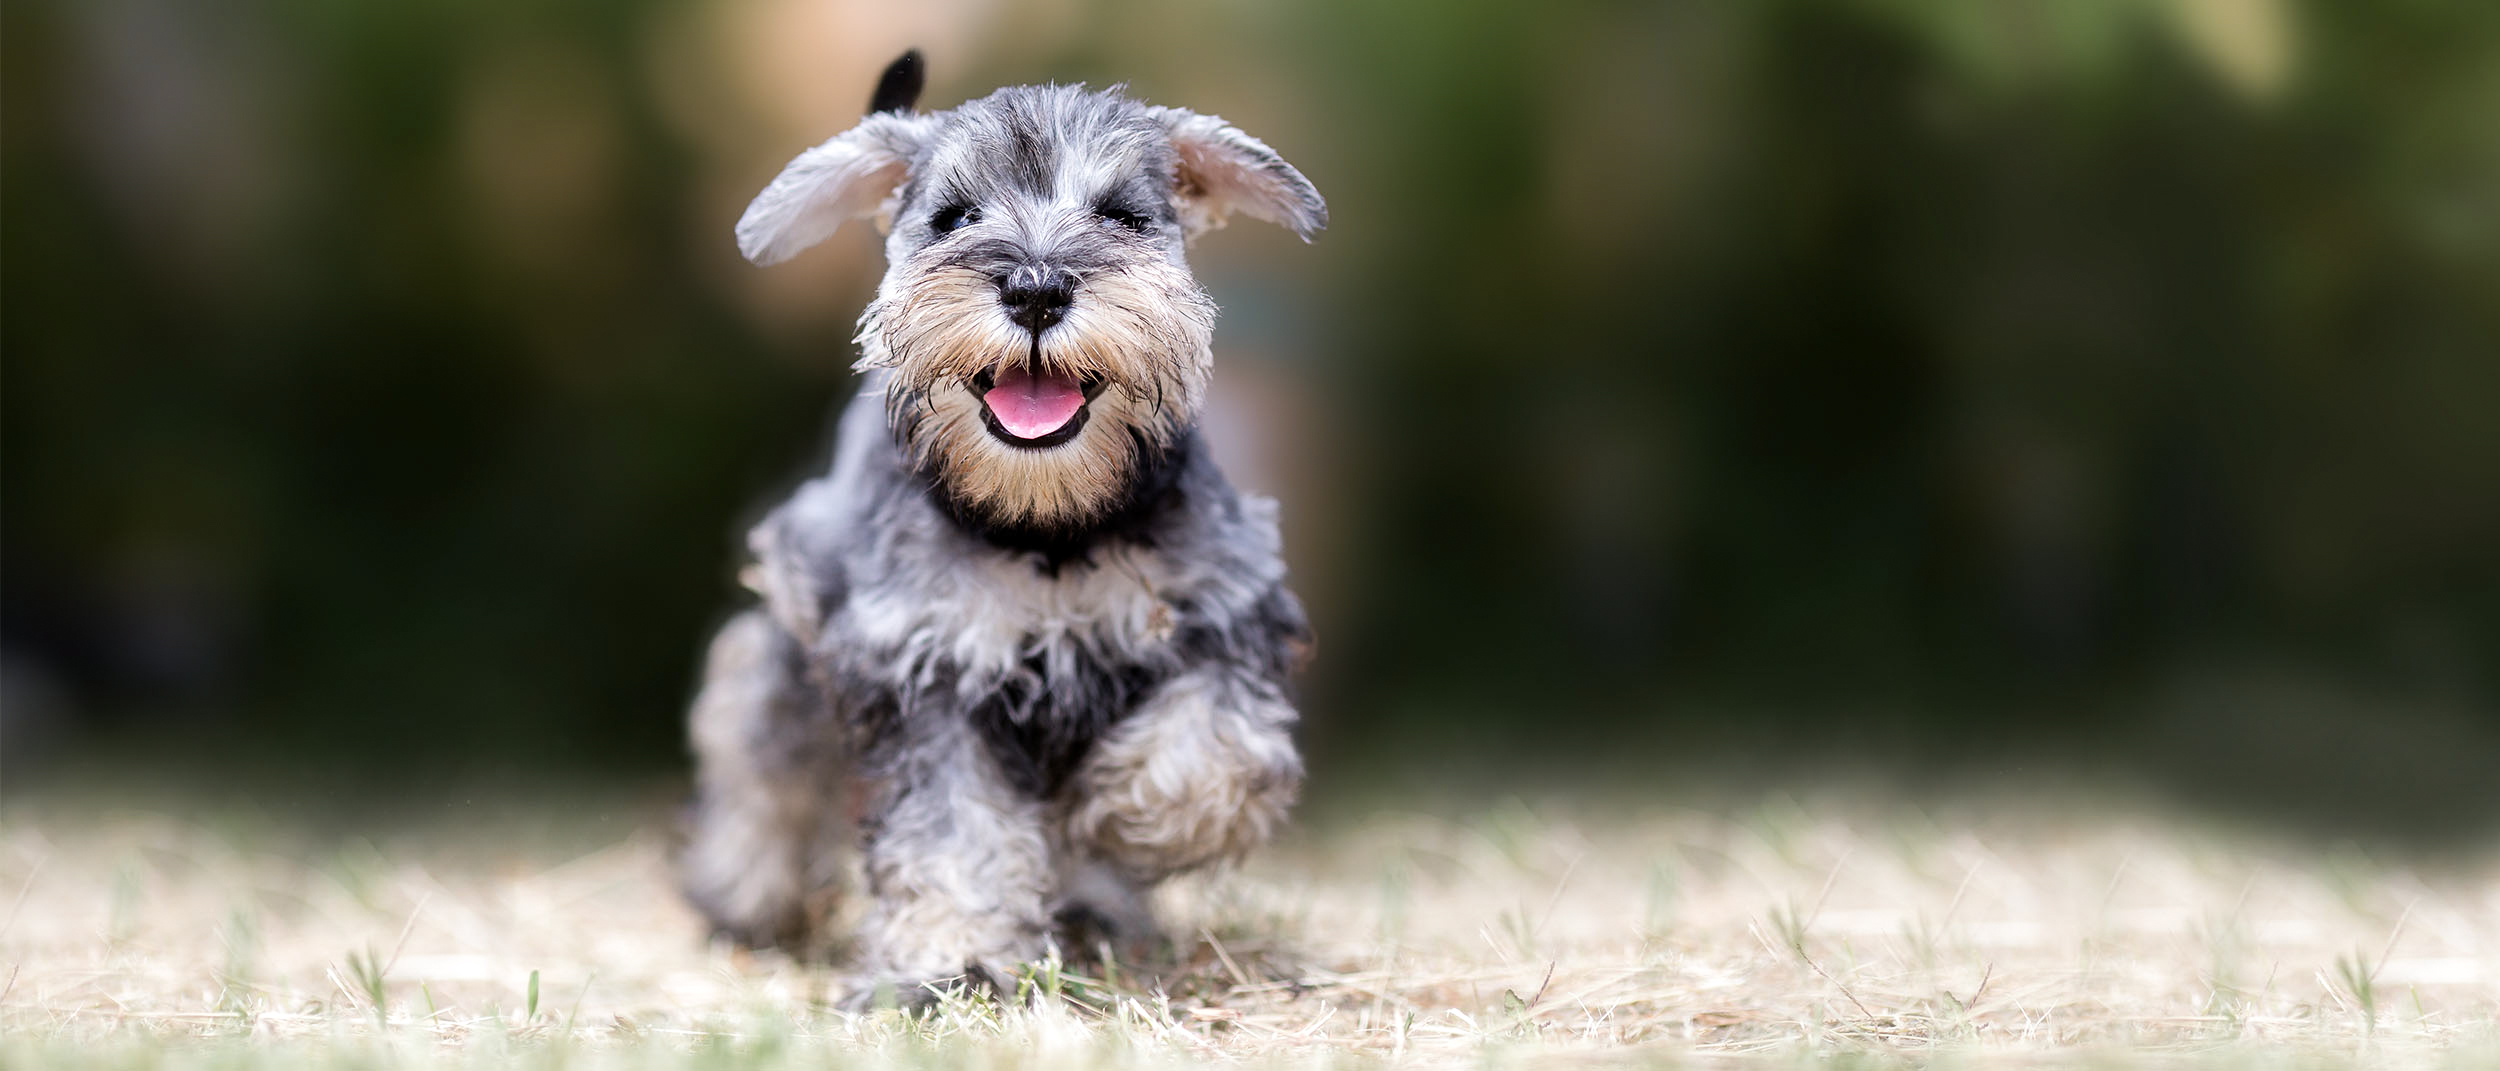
[680,53,1328,1001]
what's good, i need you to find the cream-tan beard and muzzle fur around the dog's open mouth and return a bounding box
[858,258,1215,528]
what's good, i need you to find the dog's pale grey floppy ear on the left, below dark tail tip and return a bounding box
[738,113,930,265]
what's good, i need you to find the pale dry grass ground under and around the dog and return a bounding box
[0,785,2500,1066]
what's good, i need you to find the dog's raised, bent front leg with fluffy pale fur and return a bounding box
[1065,666,1303,883]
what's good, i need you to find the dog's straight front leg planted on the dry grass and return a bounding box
[853,711,1053,1006]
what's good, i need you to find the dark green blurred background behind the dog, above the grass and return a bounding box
[0,0,2500,836]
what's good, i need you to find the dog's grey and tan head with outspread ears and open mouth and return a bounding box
[738,53,1328,528]
